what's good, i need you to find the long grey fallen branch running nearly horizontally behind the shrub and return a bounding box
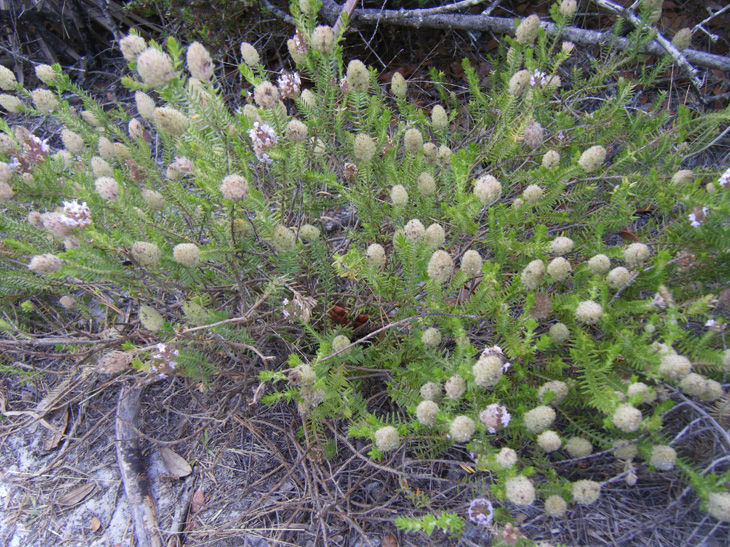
[320,0,730,72]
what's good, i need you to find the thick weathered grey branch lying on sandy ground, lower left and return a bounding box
[116,386,162,547]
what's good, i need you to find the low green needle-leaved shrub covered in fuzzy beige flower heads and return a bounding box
[0,0,730,534]
